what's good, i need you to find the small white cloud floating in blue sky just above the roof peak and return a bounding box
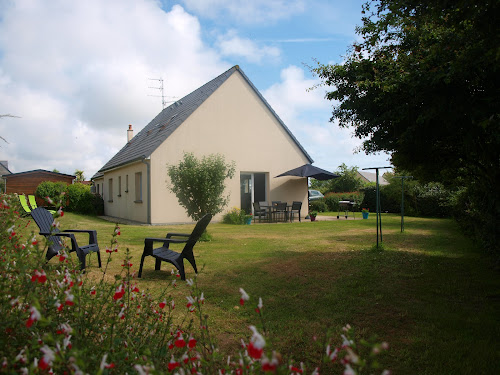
[217,30,281,64]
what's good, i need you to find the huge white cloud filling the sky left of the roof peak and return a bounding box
[0,0,228,177]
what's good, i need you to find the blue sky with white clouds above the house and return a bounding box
[0,0,389,179]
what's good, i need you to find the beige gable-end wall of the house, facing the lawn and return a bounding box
[148,72,309,224]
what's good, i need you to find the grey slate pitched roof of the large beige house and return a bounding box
[97,65,313,175]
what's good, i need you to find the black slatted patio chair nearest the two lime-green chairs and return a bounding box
[31,207,101,270]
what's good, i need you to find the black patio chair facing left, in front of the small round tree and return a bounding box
[138,214,212,280]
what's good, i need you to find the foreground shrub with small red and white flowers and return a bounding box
[0,195,387,375]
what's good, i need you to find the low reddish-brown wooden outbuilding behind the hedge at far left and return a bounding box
[2,169,76,205]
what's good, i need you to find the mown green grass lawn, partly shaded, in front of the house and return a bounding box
[22,213,500,374]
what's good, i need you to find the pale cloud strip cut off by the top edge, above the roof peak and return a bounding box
[183,0,306,24]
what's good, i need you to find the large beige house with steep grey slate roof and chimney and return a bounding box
[92,66,313,224]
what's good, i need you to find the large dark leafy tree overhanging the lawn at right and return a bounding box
[313,0,500,254]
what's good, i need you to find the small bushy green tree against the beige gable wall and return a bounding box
[167,152,235,221]
